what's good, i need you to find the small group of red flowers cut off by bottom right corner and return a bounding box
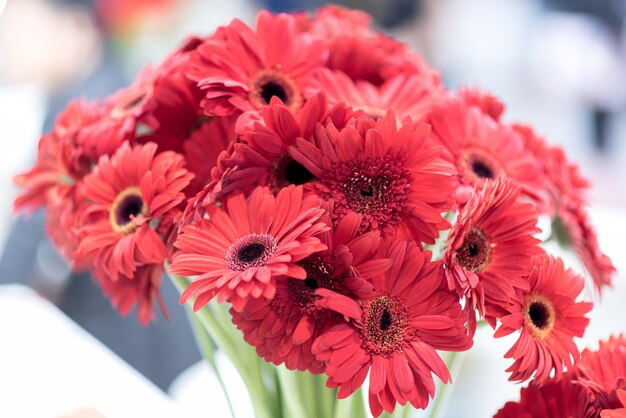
[494,335,626,418]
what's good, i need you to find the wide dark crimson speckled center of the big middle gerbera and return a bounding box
[330,155,411,233]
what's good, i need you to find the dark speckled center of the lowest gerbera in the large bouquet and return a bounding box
[361,296,410,354]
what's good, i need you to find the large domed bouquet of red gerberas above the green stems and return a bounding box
[16,7,621,416]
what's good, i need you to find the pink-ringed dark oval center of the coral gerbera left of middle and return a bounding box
[226,234,278,271]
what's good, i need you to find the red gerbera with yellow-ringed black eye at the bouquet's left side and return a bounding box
[77,142,193,280]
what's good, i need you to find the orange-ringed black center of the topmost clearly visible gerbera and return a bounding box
[249,69,302,109]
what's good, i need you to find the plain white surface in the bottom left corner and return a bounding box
[0,285,183,418]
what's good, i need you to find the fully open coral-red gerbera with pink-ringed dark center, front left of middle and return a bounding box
[170,186,328,311]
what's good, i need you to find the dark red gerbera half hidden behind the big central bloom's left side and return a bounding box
[213,94,352,195]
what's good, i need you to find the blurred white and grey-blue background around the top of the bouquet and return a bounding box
[0,0,626,417]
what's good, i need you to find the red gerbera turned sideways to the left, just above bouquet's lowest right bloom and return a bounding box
[443,180,542,323]
